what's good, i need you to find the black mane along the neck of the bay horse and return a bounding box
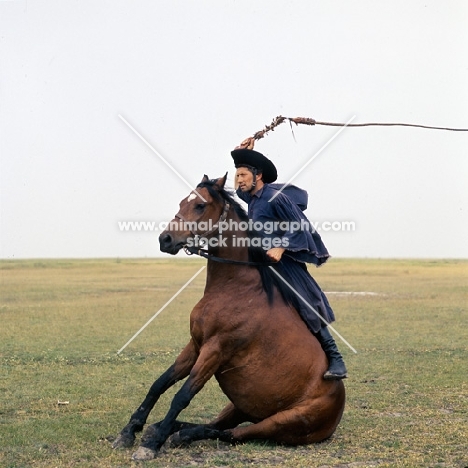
[197,179,297,305]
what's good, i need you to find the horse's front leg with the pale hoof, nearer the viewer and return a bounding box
[132,340,220,460]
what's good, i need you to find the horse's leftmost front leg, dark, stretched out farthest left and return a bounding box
[112,340,198,448]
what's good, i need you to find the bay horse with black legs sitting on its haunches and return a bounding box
[113,174,345,460]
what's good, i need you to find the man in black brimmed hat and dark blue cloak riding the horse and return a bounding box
[231,149,347,380]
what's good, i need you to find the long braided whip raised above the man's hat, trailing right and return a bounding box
[238,115,468,149]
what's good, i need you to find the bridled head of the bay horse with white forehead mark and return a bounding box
[159,173,227,255]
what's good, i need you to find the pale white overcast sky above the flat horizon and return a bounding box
[0,0,468,259]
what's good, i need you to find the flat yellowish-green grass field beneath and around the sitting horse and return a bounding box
[0,258,468,468]
